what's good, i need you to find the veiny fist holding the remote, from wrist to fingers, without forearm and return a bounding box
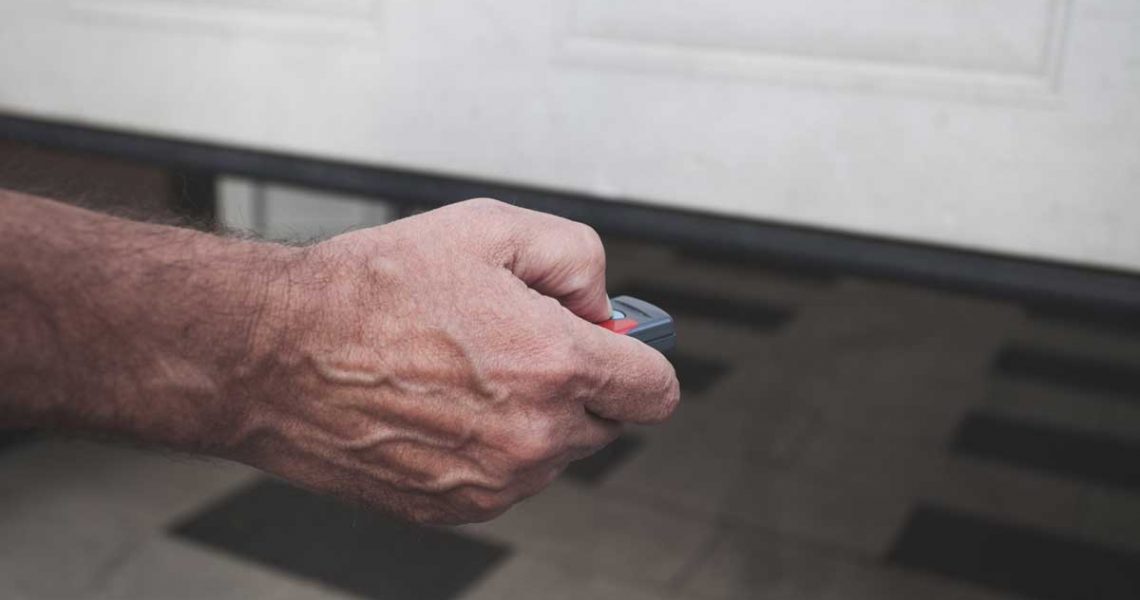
[231,200,679,524]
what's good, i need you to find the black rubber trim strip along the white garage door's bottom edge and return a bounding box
[0,115,1140,314]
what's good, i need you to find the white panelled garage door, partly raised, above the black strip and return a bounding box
[0,0,1140,270]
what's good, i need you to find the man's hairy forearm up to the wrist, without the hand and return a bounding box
[0,192,296,448]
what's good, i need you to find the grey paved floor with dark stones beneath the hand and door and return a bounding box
[0,236,1140,600]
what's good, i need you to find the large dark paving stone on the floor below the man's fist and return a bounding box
[172,479,508,600]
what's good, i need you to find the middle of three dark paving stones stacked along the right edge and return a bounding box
[951,414,1140,495]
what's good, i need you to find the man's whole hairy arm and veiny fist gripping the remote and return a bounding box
[0,193,678,524]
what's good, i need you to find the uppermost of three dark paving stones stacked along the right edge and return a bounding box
[994,346,1140,402]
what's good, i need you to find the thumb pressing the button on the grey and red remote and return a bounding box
[476,200,613,323]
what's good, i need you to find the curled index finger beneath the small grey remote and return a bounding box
[567,316,681,423]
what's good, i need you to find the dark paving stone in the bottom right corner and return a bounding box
[887,506,1140,600]
